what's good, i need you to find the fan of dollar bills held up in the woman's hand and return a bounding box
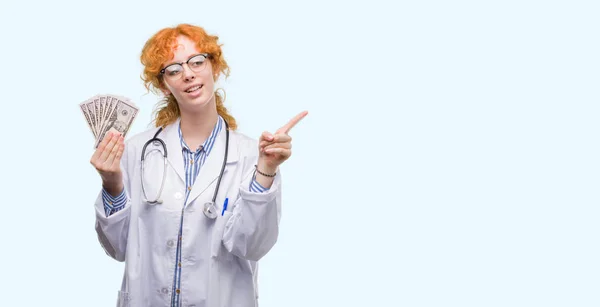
[79,95,139,148]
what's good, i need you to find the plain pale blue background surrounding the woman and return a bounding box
[0,0,600,307]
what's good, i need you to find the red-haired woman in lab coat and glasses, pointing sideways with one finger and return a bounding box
[91,24,307,307]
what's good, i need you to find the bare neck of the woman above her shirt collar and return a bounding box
[181,103,219,150]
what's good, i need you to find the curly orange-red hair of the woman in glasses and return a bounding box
[140,24,237,130]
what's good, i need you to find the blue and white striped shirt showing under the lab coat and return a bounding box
[102,116,268,306]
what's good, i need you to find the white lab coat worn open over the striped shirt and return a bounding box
[95,120,281,307]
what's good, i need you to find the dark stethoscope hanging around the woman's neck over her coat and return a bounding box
[141,121,229,219]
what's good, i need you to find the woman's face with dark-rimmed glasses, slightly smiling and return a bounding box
[163,36,215,113]
